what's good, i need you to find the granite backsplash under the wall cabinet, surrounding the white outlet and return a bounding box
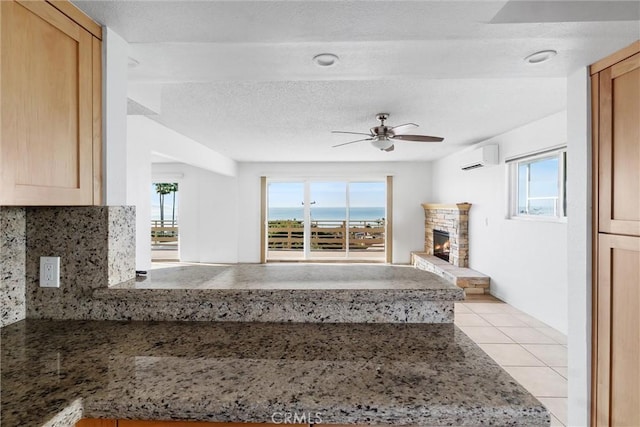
[0,206,135,326]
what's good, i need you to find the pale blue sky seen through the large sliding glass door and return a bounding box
[268,181,386,208]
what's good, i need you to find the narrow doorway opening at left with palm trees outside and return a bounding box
[151,182,180,261]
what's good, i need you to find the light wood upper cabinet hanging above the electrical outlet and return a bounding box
[0,0,102,205]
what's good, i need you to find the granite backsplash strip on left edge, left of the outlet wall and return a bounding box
[0,206,26,327]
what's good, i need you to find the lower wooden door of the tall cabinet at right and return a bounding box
[595,234,640,426]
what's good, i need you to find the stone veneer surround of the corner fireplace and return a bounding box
[422,203,471,267]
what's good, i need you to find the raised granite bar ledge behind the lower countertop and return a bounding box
[91,264,464,323]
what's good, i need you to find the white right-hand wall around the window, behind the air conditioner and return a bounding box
[430,112,571,333]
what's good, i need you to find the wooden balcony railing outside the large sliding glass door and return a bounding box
[267,220,385,252]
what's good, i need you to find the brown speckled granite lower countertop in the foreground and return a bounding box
[0,320,549,427]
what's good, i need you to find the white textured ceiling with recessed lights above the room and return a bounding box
[74,0,640,161]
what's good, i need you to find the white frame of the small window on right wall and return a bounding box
[506,146,567,222]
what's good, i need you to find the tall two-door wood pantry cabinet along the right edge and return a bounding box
[591,42,640,426]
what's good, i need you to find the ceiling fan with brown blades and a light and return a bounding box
[331,113,444,151]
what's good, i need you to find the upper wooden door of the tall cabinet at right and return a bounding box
[598,53,640,236]
